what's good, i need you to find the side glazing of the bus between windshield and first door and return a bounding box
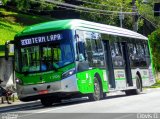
[76,31,105,67]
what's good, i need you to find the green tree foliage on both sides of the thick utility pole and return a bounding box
[81,0,160,32]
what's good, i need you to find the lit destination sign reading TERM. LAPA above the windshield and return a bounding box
[21,34,62,46]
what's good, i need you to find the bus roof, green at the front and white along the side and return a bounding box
[16,19,147,40]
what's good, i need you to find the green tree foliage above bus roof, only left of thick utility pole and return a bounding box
[81,0,135,29]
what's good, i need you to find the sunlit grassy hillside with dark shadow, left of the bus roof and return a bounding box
[0,8,53,45]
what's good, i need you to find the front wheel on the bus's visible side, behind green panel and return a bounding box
[89,77,101,101]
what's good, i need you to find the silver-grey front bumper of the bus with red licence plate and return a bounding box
[17,75,78,101]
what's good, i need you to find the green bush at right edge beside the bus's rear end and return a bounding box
[149,29,160,71]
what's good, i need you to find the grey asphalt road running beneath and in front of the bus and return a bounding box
[2,89,160,119]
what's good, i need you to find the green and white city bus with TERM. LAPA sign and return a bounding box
[6,19,155,106]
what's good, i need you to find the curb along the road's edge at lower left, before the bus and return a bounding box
[0,101,41,113]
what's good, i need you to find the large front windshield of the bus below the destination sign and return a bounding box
[16,42,73,72]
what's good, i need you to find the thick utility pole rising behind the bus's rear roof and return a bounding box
[132,0,138,31]
